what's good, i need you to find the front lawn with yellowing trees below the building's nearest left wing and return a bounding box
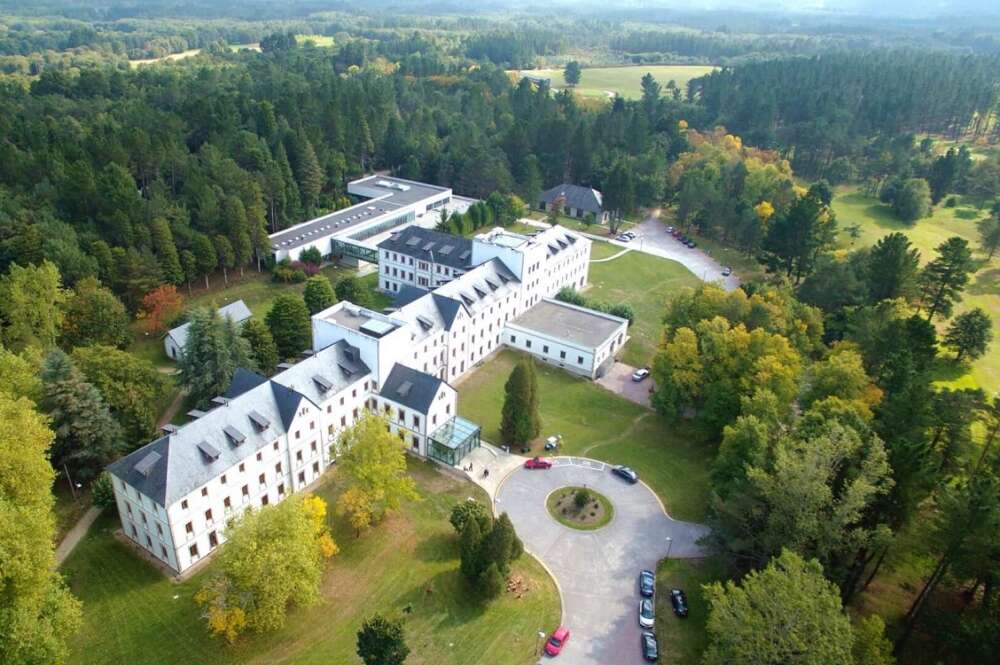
[62,461,560,665]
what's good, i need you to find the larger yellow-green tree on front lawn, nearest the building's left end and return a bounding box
[195,495,338,643]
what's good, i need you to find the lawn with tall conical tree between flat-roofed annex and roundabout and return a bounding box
[456,350,715,520]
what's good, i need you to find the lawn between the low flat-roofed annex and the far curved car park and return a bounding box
[584,249,699,367]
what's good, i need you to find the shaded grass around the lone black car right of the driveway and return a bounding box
[656,557,726,663]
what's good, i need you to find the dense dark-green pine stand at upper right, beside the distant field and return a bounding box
[689,50,1000,176]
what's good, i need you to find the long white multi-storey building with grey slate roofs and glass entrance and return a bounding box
[108,183,627,573]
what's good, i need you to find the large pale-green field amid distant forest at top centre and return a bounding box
[517,65,717,99]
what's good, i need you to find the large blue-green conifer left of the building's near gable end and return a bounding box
[40,349,123,480]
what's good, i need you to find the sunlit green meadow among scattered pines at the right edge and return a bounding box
[833,188,1000,392]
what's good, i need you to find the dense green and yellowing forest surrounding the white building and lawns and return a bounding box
[0,0,1000,665]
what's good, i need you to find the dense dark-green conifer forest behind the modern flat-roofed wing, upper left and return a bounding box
[0,42,697,311]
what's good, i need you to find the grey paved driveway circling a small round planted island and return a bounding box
[495,457,707,665]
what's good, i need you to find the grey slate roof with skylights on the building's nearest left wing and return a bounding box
[108,340,369,507]
